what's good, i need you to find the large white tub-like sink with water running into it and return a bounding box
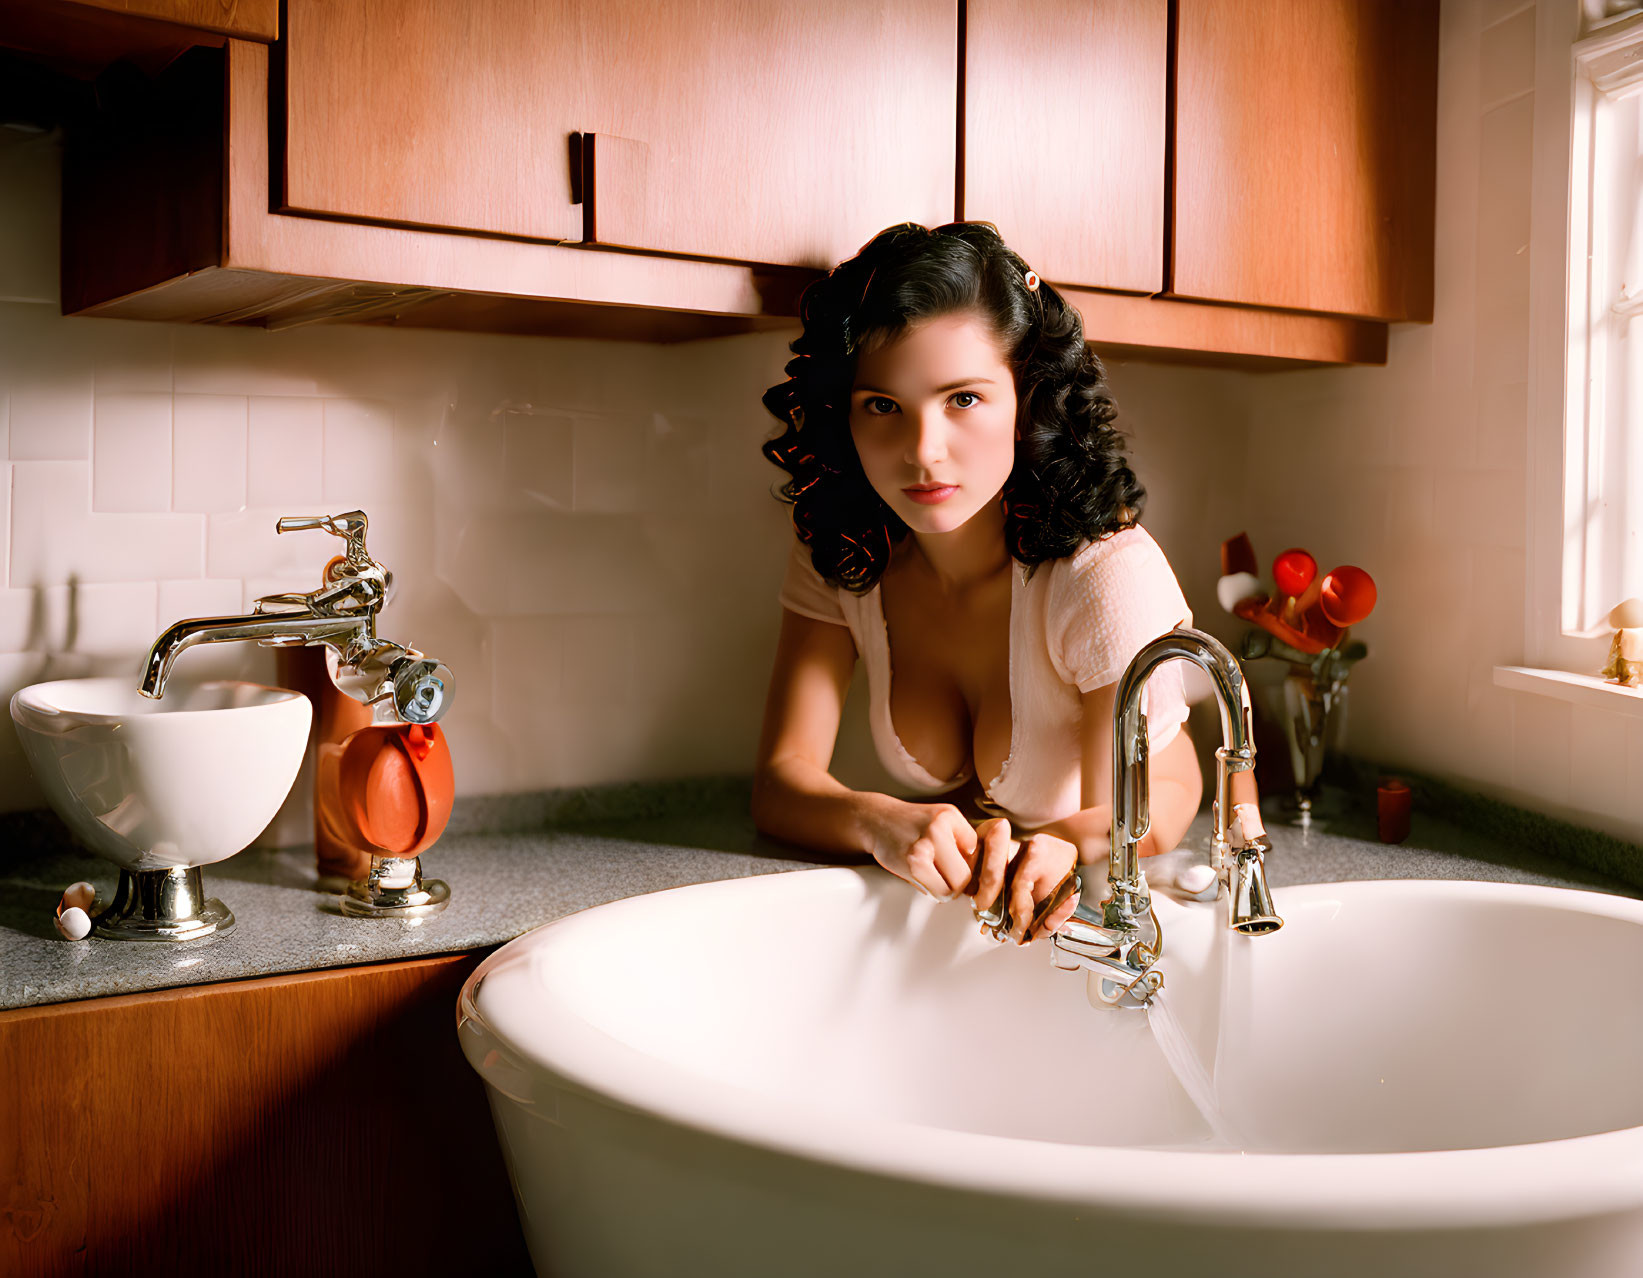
[458,867,1643,1278]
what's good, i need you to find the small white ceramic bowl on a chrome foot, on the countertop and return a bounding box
[12,678,311,871]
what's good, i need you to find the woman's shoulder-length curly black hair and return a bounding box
[761,222,1147,595]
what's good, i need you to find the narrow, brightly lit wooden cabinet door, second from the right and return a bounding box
[961,0,1168,292]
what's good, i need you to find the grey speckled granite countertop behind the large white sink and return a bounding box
[0,782,1643,1010]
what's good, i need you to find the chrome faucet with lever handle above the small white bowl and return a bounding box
[138,511,455,723]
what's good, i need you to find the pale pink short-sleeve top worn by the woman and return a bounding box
[779,526,1193,830]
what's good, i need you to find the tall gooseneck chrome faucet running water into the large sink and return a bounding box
[979,626,1283,1007]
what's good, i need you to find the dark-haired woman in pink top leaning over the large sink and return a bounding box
[752,223,1235,943]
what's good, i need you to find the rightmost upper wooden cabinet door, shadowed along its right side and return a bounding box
[1170,0,1438,320]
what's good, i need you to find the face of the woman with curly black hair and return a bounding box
[849,314,1015,532]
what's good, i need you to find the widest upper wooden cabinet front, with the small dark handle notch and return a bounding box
[274,0,958,269]
